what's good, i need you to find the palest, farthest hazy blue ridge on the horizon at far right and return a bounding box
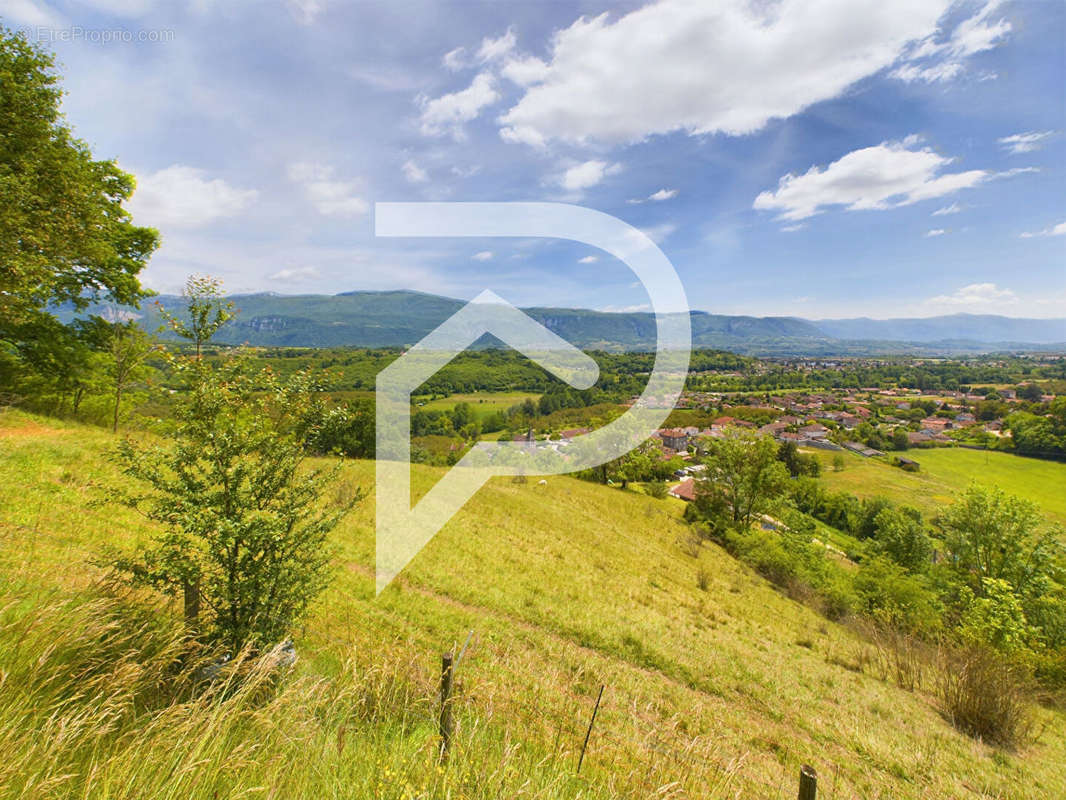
[814,314,1066,345]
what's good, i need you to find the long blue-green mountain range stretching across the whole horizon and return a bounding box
[61,291,1066,355]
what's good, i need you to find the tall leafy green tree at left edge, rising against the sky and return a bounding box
[0,28,159,332]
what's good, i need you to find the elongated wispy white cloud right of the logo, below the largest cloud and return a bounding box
[753,140,992,221]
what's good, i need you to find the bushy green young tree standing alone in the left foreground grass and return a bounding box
[113,358,361,652]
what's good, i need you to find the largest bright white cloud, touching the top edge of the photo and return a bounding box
[500,0,950,146]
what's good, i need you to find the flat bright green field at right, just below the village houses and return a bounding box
[811,447,1066,525]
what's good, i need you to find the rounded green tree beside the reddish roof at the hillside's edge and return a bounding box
[696,429,789,530]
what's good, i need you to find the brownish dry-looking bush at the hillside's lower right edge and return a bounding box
[937,646,1035,749]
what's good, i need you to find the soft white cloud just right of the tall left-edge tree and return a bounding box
[129,164,259,229]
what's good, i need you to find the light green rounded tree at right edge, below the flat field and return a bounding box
[942,484,1061,596]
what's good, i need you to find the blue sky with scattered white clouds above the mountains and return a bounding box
[0,0,1066,319]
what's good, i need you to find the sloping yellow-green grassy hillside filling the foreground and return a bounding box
[6,413,1066,799]
